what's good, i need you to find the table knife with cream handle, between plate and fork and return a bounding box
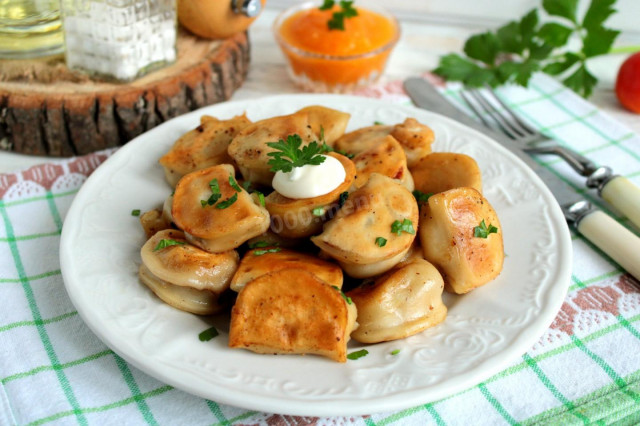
[404,77,640,280]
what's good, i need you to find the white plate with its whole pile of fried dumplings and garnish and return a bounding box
[60,94,572,416]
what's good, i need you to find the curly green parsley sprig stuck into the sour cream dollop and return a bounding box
[267,134,325,173]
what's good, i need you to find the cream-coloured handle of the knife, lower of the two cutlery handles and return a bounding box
[578,210,640,280]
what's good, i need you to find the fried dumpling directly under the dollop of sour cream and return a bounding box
[265,152,356,238]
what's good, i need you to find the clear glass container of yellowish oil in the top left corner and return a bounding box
[0,0,64,59]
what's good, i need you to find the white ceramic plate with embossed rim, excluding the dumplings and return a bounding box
[60,95,572,416]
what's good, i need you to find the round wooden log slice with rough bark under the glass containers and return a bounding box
[0,31,250,157]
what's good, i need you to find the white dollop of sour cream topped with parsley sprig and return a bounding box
[271,155,347,200]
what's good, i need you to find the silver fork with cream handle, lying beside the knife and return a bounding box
[460,88,640,228]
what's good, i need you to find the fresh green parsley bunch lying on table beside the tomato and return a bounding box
[434,0,620,97]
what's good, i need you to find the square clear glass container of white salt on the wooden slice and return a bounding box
[62,0,177,81]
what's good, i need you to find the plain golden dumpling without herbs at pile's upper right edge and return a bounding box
[411,152,482,194]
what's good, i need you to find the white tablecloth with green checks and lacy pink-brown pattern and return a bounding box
[0,76,640,426]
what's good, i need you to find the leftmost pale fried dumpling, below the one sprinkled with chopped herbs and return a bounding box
[139,229,239,315]
